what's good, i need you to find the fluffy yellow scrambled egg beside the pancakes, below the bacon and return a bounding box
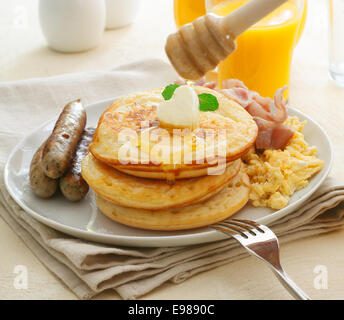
[243,117,324,209]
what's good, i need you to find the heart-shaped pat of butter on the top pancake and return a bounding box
[157,86,199,129]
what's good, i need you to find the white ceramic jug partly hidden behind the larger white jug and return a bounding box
[106,0,140,29]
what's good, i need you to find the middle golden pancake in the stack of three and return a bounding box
[81,153,241,210]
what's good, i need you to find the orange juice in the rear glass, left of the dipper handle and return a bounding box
[174,0,206,28]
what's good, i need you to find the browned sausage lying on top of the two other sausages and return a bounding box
[42,100,86,179]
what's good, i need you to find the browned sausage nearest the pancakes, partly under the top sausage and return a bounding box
[60,128,95,201]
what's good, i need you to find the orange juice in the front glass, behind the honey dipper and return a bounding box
[212,0,305,98]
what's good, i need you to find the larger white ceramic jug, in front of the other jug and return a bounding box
[39,0,106,52]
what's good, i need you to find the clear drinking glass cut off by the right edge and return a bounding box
[328,0,344,87]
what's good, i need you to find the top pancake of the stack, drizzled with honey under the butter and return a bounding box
[90,86,258,179]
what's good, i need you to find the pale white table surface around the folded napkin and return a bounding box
[0,0,344,300]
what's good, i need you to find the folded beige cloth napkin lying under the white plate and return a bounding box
[0,60,344,299]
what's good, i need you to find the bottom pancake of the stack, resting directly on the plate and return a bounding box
[96,172,250,231]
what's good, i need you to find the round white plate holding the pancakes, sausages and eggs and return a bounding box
[5,99,333,247]
